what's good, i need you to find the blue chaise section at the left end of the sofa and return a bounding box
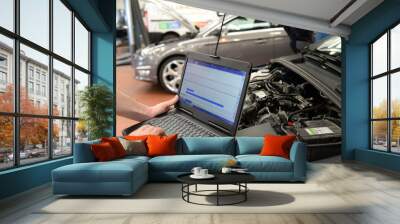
[52,156,148,195]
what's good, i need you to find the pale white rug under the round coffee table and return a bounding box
[37,183,360,214]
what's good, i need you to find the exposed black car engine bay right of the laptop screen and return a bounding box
[239,66,341,160]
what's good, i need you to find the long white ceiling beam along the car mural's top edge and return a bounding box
[169,0,350,37]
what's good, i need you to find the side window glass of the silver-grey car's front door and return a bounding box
[224,17,271,33]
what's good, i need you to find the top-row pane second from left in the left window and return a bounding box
[20,0,49,48]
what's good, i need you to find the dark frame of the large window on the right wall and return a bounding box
[368,21,400,155]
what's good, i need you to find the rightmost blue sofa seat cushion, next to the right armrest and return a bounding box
[236,155,293,172]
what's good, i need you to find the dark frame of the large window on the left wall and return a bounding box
[0,0,93,172]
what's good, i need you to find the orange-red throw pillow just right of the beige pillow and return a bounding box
[146,134,178,157]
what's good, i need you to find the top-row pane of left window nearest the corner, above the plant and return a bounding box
[75,18,89,70]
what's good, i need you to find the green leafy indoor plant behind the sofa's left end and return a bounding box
[79,84,113,140]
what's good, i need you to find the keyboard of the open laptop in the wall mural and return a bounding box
[146,114,217,137]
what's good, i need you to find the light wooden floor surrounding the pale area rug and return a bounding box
[0,158,400,224]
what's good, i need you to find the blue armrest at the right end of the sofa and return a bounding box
[290,141,307,181]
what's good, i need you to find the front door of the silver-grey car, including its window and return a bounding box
[211,16,274,66]
